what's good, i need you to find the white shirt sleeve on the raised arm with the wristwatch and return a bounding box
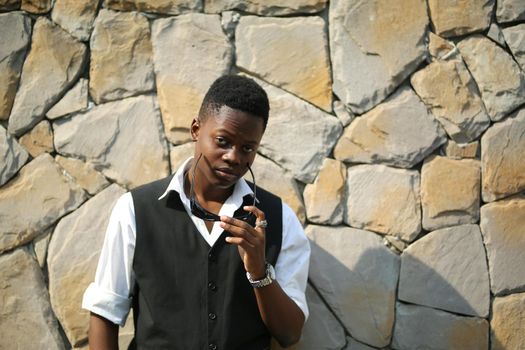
[275,202,310,321]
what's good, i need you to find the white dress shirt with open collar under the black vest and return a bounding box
[82,158,310,326]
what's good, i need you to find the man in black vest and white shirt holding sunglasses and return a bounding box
[83,76,310,350]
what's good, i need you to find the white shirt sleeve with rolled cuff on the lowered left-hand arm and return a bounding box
[82,192,136,326]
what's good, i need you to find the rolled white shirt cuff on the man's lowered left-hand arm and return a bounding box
[82,283,131,327]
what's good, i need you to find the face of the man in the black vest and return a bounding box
[191,106,264,188]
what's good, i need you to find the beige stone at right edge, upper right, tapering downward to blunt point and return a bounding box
[458,35,525,121]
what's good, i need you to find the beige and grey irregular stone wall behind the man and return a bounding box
[0,0,525,350]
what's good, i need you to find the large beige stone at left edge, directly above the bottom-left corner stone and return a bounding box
[0,153,86,252]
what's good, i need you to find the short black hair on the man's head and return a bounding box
[199,75,270,129]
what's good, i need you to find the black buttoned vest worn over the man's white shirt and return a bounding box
[131,176,282,350]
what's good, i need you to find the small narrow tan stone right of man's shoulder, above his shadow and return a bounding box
[303,158,346,225]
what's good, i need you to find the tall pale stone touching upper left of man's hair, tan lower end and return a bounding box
[152,13,233,144]
